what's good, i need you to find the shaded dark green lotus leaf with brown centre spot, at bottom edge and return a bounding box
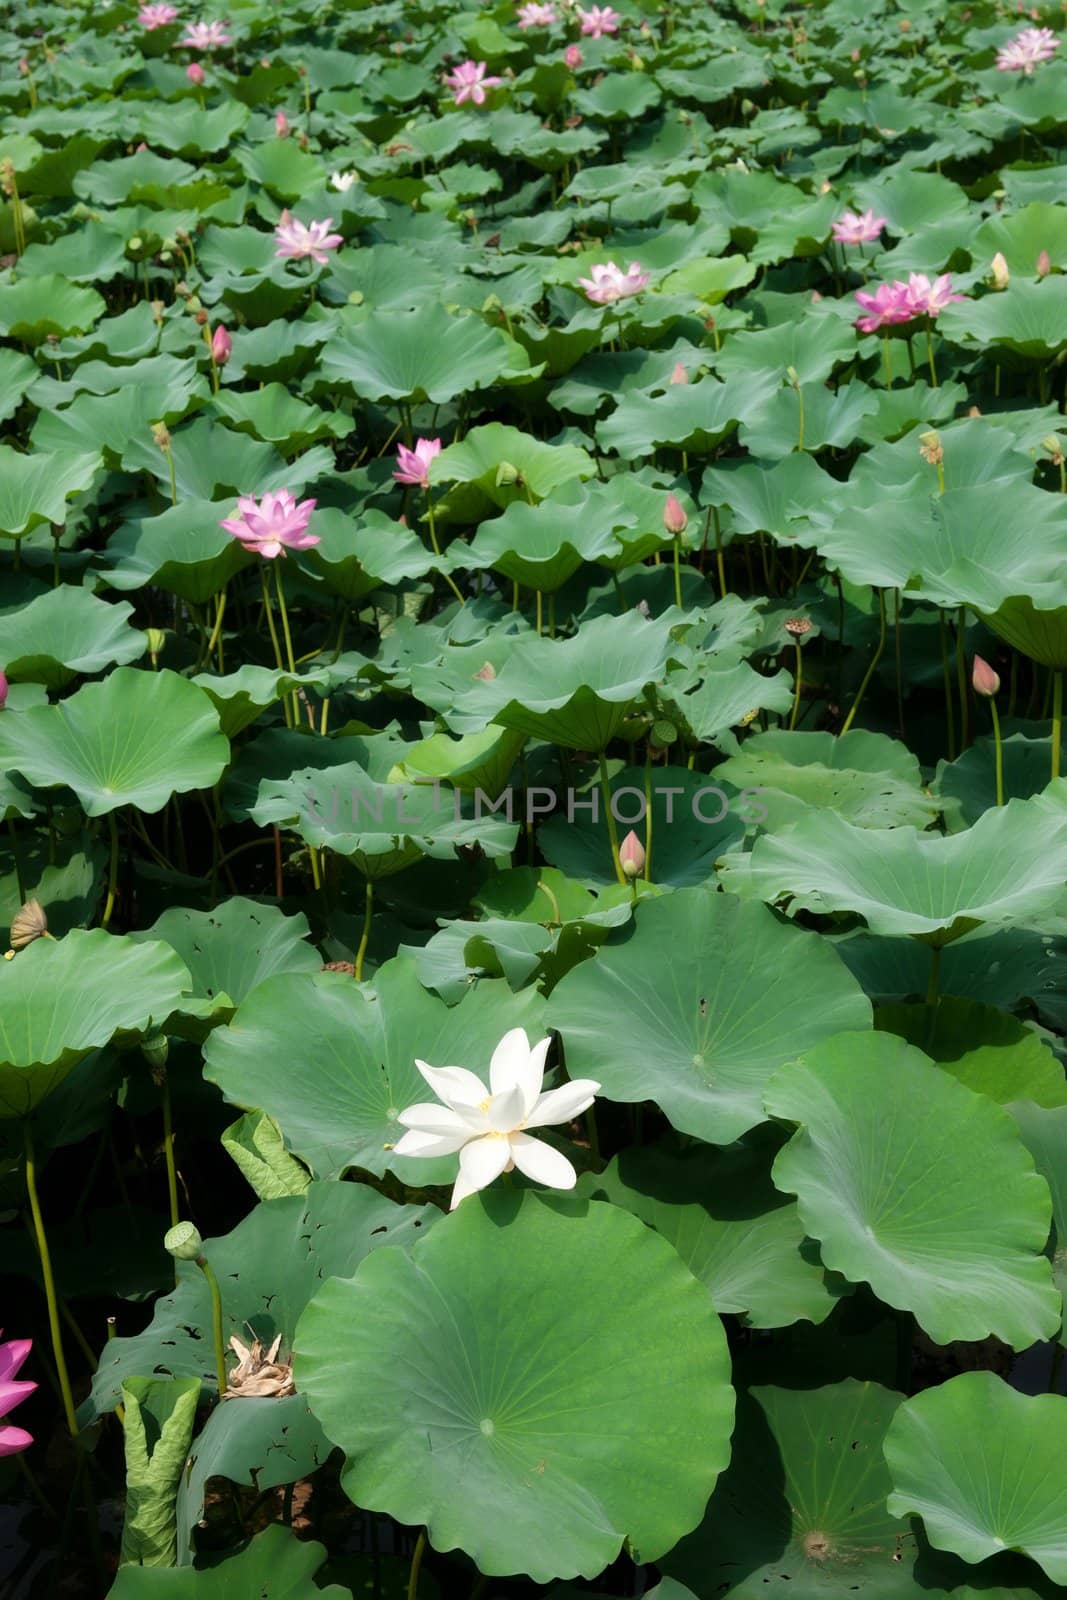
[662,1379,926,1600]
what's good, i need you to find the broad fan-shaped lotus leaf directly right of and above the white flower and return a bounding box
[549,890,870,1144]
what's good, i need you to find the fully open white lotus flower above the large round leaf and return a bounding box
[394,1027,600,1211]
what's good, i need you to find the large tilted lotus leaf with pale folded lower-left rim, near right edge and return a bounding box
[765,1034,1062,1350]
